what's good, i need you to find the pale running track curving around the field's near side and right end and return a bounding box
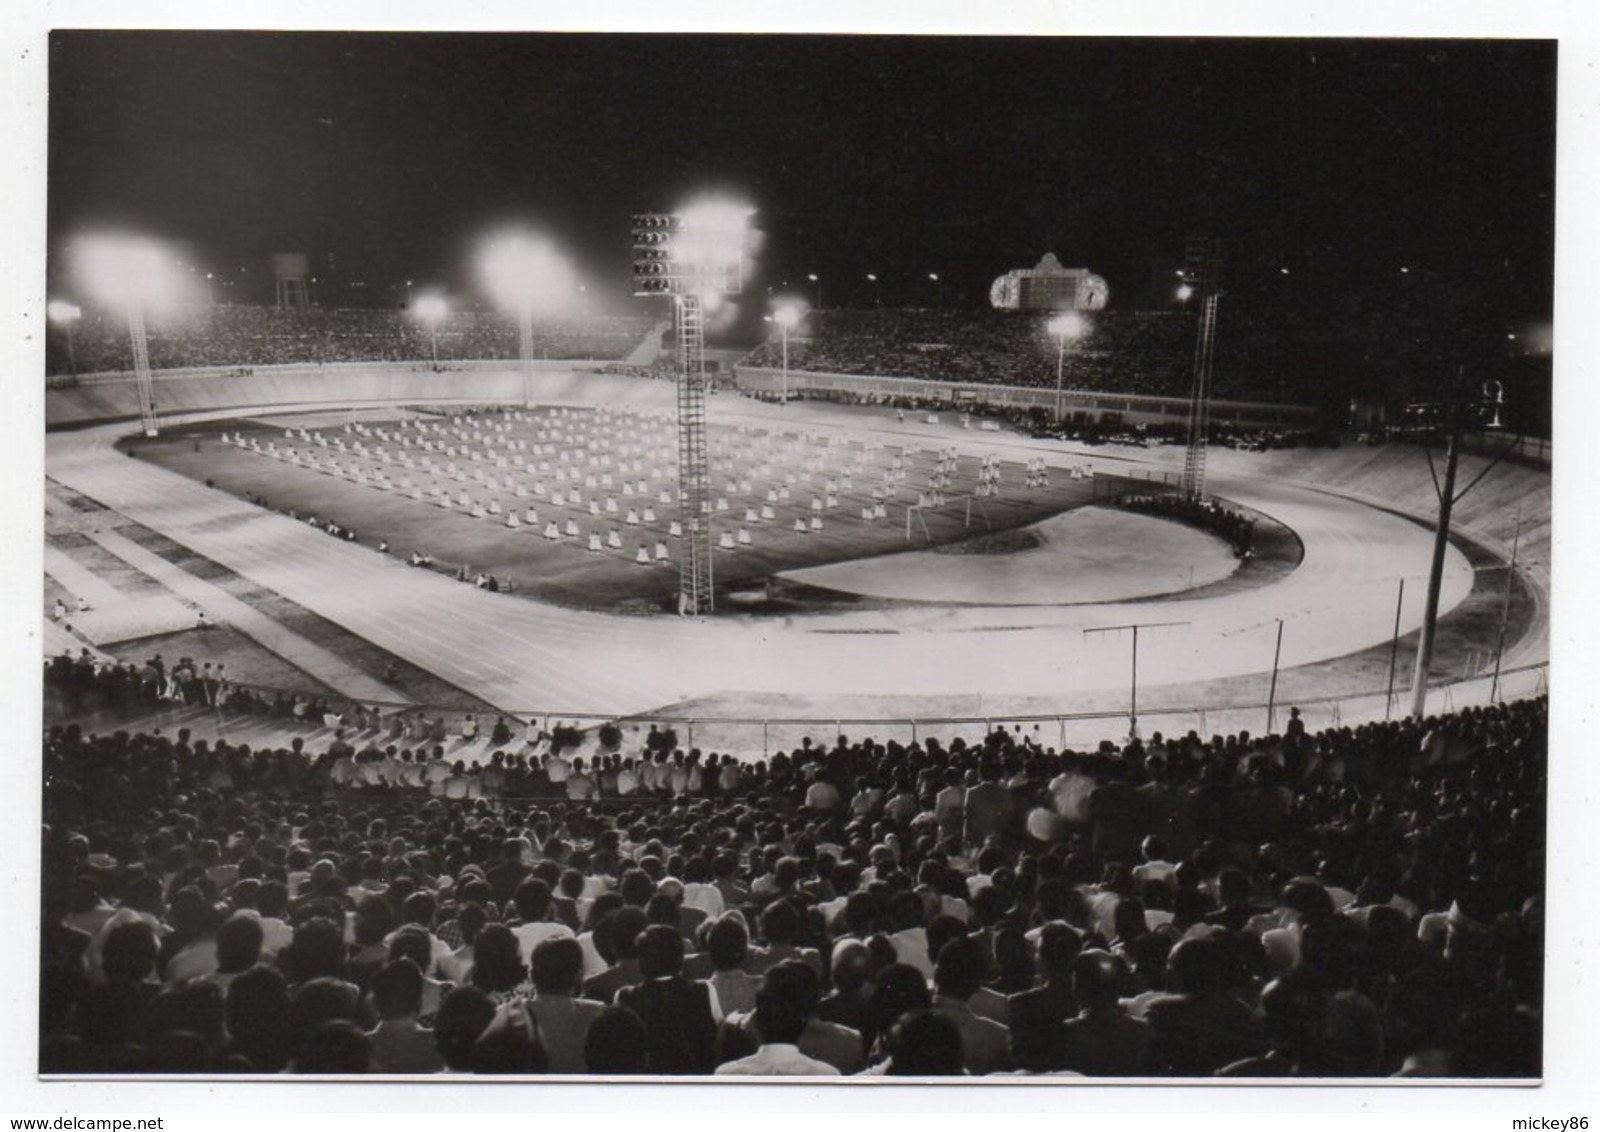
[46,403,1472,715]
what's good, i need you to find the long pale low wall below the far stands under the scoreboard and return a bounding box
[734,366,1322,428]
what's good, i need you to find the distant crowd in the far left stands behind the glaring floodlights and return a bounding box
[46,305,651,374]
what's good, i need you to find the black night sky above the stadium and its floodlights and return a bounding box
[50,32,1555,329]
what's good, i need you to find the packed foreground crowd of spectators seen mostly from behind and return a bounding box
[40,699,1547,1078]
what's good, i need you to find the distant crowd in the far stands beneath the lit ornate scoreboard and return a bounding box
[744,310,1203,397]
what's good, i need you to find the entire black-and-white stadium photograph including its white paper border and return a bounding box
[8,2,1592,1114]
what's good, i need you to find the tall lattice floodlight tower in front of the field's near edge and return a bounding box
[632,205,749,616]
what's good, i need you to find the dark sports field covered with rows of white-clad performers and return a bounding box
[126,406,1139,611]
